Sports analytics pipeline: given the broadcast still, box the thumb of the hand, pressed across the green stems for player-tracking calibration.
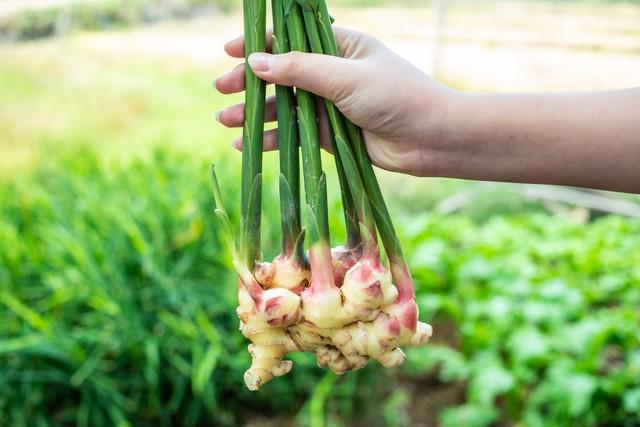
[247,52,356,101]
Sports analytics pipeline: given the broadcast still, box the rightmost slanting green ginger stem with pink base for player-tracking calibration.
[313,0,415,301]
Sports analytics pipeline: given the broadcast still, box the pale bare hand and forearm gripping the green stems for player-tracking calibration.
[215,28,640,193]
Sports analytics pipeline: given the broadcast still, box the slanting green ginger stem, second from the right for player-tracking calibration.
[302,3,376,241]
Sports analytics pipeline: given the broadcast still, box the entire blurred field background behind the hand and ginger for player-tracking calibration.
[0,1,640,427]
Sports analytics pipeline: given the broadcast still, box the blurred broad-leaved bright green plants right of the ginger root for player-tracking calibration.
[401,215,640,426]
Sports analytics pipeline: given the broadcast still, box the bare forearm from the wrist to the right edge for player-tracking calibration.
[432,89,640,192]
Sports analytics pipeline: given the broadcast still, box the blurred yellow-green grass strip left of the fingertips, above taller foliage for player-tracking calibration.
[0,47,237,171]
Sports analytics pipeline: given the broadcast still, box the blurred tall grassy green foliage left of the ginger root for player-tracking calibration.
[0,145,404,426]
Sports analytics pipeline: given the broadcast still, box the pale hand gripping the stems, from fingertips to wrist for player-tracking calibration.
[216,28,453,175]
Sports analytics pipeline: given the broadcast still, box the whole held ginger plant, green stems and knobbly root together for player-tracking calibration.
[211,0,432,390]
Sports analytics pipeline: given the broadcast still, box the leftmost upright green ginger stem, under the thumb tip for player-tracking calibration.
[240,0,266,270]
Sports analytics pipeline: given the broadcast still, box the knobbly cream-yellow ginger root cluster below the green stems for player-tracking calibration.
[232,251,432,390]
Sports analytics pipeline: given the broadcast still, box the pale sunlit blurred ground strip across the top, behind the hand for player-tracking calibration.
[5,0,640,91]
